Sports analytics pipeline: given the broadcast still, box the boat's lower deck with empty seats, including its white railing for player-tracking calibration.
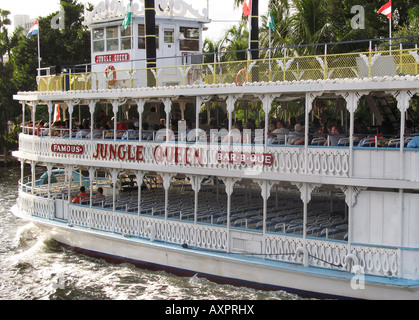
[18,171,403,279]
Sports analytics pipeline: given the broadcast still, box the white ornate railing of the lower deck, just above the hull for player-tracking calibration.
[18,192,400,277]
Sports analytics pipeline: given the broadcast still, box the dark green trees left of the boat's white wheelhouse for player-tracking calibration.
[0,0,91,147]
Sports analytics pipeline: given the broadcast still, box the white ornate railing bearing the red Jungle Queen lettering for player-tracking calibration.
[19,135,349,177]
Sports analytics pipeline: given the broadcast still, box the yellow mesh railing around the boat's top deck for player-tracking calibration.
[37,48,419,91]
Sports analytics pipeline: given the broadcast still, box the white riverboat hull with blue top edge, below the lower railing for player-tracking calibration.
[12,206,419,300]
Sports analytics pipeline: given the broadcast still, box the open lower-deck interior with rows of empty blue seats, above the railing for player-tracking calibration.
[27,176,348,240]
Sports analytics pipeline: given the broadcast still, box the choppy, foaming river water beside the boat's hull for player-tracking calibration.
[0,165,303,300]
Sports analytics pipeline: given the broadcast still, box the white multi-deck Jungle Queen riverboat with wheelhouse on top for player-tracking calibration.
[9,0,419,299]
